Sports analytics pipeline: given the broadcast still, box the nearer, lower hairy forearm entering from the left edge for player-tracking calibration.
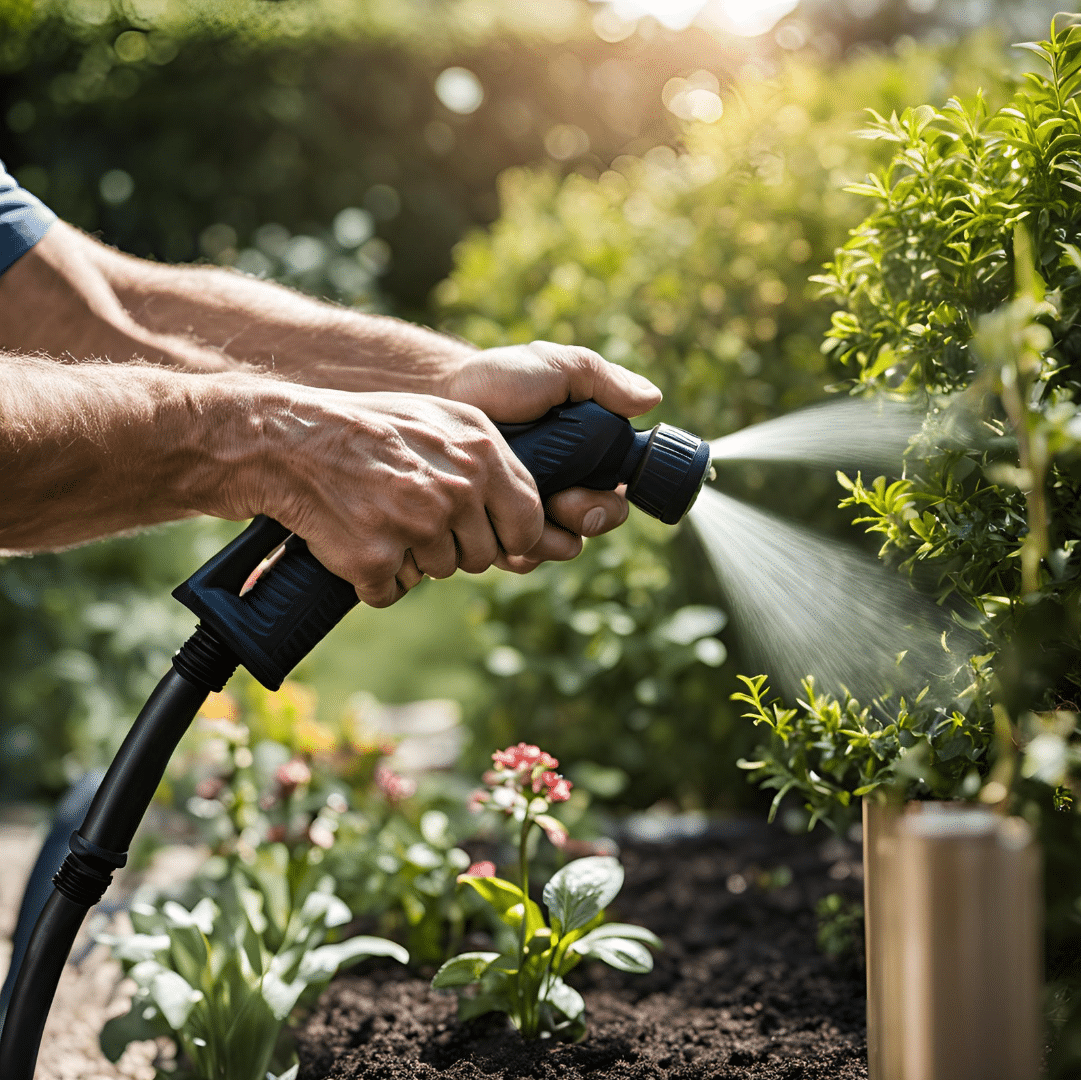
[0,354,261,554]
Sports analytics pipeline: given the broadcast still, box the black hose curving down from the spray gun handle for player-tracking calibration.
[0,626,238,1080]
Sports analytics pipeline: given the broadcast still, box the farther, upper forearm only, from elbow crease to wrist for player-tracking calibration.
[84,228,476,395]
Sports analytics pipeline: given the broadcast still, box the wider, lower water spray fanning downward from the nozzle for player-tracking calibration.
[690,486,978,703]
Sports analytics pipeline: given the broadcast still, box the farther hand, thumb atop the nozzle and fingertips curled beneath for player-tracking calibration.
[442,342,660,573]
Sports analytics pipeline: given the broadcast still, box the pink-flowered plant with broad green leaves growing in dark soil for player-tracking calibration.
[431,743,660,1041]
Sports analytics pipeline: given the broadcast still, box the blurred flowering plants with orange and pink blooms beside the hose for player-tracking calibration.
[170,680,469,963]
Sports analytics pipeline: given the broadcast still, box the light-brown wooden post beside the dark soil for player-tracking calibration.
[864,800,1042,1080]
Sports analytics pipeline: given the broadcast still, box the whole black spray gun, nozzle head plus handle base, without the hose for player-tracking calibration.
[173,401,710,690]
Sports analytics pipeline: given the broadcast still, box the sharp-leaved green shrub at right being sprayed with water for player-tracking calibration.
[744,17,1081,1077]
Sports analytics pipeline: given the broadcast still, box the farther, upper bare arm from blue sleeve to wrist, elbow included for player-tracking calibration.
[0,222,476,395]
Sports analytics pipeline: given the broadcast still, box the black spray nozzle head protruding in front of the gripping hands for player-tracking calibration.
[497,401,710,525]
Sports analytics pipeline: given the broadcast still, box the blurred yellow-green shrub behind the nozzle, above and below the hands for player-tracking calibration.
[437,31,1005,805]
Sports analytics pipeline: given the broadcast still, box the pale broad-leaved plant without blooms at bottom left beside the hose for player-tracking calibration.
[101,844,409,1080]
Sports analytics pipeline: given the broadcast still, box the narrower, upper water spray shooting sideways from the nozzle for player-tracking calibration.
[709,398,926,474]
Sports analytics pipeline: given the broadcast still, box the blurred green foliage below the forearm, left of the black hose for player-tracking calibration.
[0,522,228,800]
